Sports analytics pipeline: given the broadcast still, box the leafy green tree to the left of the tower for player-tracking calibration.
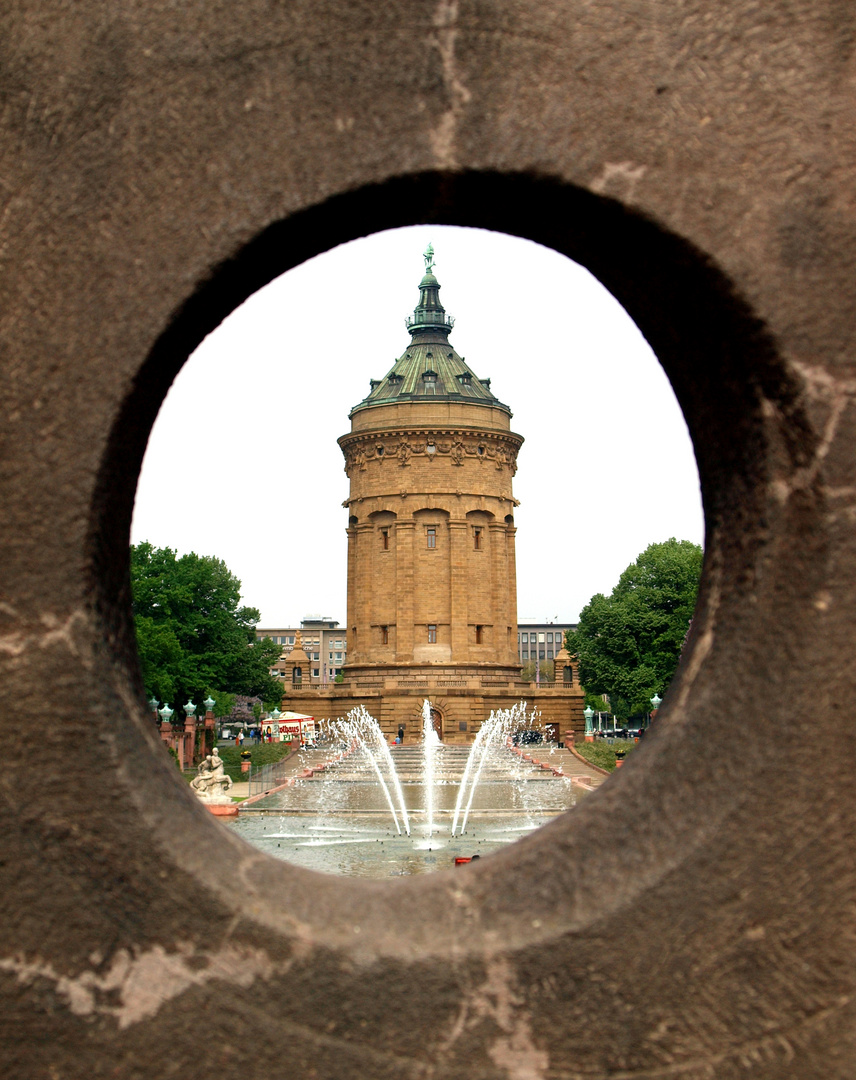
[131,542,282,708]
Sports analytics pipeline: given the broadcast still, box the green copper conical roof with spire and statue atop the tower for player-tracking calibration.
[351,244,512,416]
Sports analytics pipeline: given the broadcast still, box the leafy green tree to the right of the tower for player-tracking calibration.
[567,537,702,719]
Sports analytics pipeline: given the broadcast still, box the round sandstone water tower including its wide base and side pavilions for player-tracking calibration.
[276,246,583,743]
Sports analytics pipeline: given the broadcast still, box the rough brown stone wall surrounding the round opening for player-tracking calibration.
[0,0,856,1080]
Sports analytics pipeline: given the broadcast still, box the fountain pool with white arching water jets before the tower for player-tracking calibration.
[228,700,580,877]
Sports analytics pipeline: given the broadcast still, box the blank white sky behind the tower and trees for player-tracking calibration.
[132,226,704,627]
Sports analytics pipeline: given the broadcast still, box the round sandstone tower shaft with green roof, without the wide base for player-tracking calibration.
[339,246,522,678]
